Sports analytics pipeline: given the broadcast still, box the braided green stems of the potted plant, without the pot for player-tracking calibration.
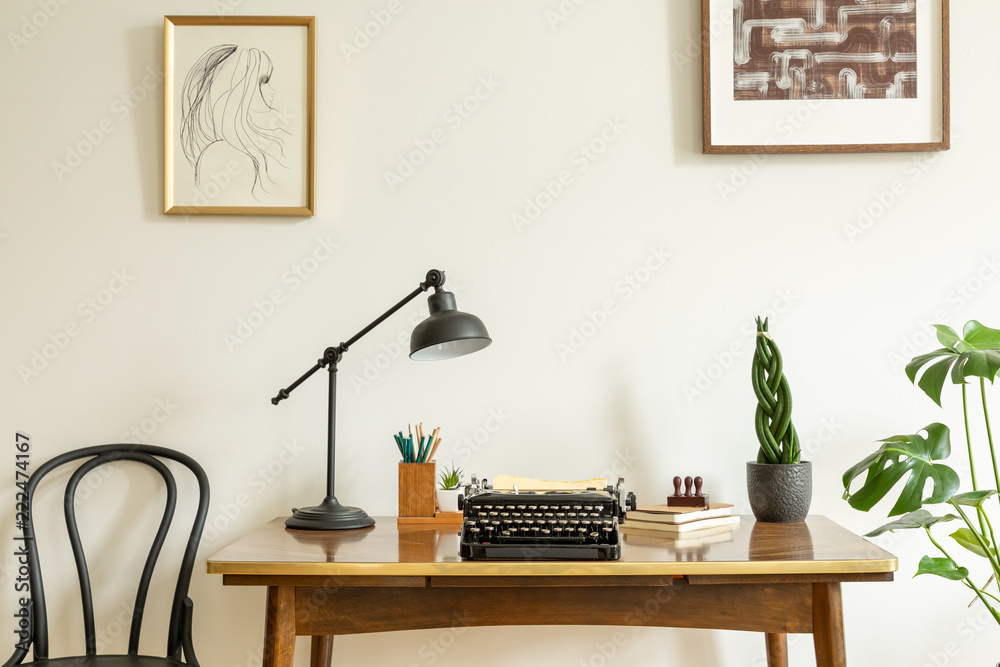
[751,317,802,463]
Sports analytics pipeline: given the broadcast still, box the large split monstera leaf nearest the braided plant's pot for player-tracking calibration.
[843,423,959,516]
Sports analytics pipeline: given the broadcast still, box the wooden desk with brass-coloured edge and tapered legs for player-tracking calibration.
[208,516,897,667]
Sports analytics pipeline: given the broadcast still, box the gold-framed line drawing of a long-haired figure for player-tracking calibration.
[163,16,316,216]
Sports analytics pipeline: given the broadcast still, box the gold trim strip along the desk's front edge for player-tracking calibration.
[206,558,899,577]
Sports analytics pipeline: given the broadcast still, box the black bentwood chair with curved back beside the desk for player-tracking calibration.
[3,445,209,667]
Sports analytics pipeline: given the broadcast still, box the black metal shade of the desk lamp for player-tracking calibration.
[410,291,493,361]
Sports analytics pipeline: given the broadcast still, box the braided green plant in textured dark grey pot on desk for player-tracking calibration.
[747,317,812,523]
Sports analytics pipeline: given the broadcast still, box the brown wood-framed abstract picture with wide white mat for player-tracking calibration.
[702,0,951,154]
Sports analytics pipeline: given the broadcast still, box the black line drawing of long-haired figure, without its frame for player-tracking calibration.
[180,44,290,199]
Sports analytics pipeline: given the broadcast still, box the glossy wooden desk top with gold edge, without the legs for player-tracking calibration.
[207,516,897,576]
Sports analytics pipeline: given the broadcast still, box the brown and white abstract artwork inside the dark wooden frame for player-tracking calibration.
[733,0,917,100]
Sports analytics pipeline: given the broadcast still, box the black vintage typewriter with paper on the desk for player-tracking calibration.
[459,478,635,560]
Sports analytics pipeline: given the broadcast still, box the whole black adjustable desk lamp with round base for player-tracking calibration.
[271,269,493,530]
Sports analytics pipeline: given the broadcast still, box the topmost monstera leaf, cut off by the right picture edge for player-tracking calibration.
[906,320,1000,405]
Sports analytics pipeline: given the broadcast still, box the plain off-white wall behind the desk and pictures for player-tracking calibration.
[0,0,1000,667]
